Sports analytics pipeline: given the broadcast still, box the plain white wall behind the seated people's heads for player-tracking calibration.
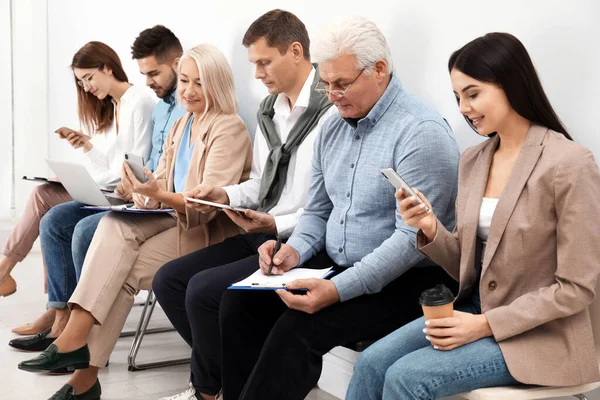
[48,0,600,162]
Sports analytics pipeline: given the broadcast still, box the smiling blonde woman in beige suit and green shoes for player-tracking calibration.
[19,44,252,399]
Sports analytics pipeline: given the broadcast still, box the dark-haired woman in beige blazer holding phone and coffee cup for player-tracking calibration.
[347,33,600,400]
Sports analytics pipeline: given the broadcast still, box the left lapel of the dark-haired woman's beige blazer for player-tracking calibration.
[460,135,499,282]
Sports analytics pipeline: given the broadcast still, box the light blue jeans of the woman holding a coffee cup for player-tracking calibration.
[346,294,518,400]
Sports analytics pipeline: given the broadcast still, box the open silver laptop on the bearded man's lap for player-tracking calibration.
[46,160,130,206]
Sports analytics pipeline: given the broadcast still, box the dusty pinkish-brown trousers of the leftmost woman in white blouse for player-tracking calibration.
[2,183,73,293]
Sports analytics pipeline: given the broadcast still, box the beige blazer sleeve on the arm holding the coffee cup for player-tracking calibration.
[485,149,600,341]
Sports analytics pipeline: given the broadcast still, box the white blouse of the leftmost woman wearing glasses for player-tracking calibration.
[85,85,156,189]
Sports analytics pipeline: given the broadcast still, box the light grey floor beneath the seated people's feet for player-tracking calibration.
[0,250,336,400]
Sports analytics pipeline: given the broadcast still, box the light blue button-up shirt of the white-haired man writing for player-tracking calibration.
[287,75,460,301]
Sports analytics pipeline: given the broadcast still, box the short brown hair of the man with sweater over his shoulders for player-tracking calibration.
[242,9,310,60]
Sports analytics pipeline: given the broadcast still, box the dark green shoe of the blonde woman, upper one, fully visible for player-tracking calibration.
[19,344,90,372]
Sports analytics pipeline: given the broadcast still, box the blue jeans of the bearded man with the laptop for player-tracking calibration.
[40,201,106,308]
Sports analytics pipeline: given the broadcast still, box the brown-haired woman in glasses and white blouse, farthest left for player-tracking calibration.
[0,42,155,337]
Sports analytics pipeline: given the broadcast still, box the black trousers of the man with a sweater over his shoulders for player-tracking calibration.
[152,234,275,395]
